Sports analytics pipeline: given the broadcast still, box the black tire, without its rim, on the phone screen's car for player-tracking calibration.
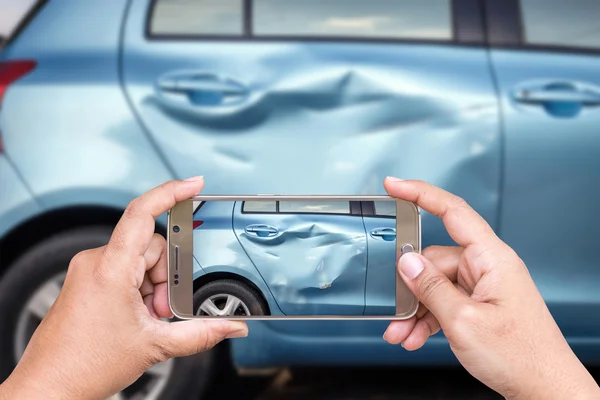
[194,279,269,315]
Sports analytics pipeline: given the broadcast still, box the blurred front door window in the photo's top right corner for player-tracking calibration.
[521,0,600,49]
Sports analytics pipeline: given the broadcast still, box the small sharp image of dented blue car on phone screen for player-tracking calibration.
[193,201,396,316]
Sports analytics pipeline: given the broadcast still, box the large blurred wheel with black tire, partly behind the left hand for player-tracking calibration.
[0,227,227,400]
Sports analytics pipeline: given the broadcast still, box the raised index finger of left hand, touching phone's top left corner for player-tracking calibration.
[108,177,204,265]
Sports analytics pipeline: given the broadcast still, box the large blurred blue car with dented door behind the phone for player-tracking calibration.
[0,0,600,399]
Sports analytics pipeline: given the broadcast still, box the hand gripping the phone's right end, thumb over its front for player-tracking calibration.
[384,178,600,399]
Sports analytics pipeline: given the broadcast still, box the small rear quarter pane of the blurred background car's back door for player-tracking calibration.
[150,0,244,35]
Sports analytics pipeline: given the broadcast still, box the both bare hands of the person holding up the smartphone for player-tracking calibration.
[0,177,600,400]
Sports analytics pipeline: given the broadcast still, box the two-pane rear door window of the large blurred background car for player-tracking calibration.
[149,0,453,40]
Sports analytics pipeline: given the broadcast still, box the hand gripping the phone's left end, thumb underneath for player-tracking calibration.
[0,177,248,399]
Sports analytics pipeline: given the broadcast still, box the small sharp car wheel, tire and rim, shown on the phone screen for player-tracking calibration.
[194,279,269,316]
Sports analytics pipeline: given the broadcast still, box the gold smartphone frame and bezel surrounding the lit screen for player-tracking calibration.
[167,194,421,321]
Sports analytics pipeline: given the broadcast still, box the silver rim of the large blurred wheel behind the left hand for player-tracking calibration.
[14,272,174,400]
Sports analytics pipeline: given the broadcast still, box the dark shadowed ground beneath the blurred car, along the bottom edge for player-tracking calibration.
[203,368,600,400]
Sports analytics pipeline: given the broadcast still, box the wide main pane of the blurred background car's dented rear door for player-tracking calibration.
[252,0,452,40]
